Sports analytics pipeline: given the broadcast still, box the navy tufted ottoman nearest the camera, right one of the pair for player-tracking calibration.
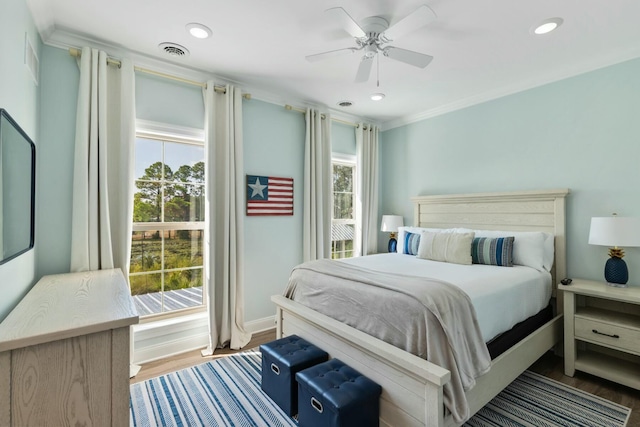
[296,359,382,427]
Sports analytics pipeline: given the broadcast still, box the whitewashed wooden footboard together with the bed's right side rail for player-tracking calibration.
[271,295,562,427]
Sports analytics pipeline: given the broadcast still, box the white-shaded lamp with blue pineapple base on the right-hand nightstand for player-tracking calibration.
[589,214,640,288]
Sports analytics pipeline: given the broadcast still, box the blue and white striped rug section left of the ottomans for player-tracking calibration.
[130,351,297,427]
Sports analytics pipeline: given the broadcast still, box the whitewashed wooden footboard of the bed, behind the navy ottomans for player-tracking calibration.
[271,295,451,427]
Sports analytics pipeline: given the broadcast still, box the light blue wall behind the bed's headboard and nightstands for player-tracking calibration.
[380,56,640,285]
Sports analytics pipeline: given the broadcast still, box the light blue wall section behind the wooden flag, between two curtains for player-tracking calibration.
[243,100,305,321]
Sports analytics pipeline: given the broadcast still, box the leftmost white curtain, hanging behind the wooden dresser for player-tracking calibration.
[70,47,135,277]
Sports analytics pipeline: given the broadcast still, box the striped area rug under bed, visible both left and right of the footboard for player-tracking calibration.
[130,351,631,427]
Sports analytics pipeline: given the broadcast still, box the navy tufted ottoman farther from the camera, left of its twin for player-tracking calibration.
[260,335,329,416]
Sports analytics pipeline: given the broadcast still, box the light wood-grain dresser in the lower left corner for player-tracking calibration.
[0,269,138,427]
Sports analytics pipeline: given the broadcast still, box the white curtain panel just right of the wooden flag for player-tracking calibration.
[302,109,333,261]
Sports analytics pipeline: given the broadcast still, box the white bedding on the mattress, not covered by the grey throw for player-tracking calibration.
[341,253,551,342]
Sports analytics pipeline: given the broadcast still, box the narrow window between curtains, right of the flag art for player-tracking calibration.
[331,157,356,259]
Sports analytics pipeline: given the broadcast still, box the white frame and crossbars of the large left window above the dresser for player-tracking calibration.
[129,120,208,323]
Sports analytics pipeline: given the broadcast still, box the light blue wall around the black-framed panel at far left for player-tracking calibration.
[0,0,42,321]
